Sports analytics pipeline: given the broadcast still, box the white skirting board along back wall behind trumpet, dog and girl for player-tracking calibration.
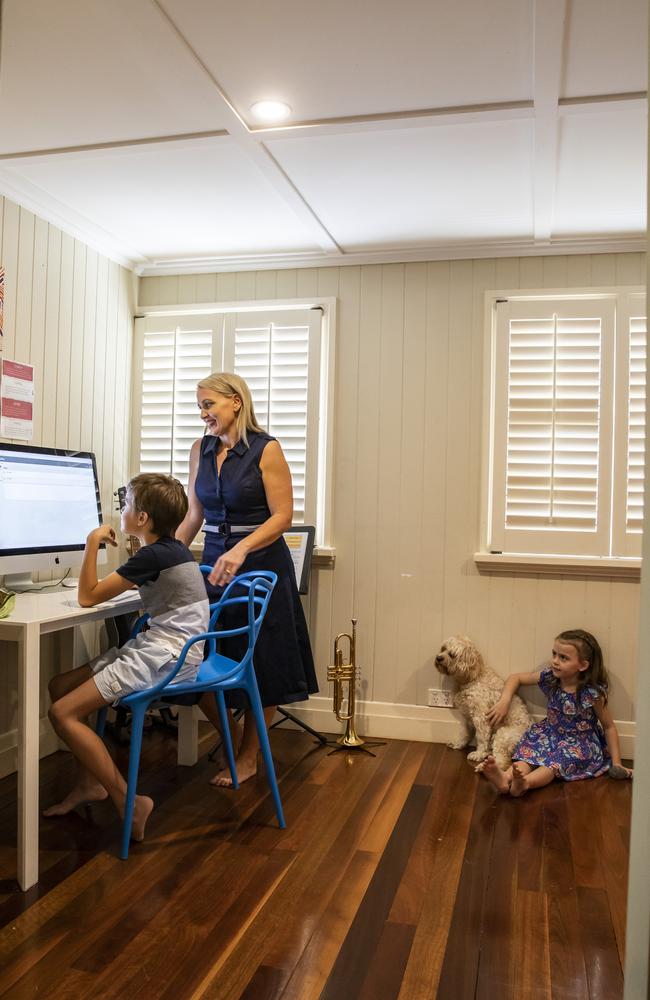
[284,696,635,760]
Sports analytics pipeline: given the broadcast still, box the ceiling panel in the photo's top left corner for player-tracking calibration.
[0,0,227,153]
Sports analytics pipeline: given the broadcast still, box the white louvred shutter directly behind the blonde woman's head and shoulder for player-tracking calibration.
[224,309,321,524]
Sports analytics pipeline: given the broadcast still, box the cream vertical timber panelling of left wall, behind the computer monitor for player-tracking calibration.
[0,198,137,774]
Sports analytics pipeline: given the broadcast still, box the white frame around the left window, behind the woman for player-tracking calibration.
[129,296,338,558]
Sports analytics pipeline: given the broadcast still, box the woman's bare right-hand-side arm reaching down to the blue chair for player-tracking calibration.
[208,441,293,586]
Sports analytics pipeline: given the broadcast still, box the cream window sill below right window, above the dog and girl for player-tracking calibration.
[474,552,641,582]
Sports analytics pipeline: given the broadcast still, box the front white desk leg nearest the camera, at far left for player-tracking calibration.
[17,624,41,891]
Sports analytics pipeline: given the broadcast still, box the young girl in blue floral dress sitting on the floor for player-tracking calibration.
[483,629,632,796]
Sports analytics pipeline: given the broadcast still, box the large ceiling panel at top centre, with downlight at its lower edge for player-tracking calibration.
[165,0,532,124]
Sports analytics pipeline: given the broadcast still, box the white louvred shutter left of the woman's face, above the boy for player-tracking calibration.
[137,316,215,486]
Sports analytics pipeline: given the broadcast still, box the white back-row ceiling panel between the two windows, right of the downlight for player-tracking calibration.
[269,121,532,250]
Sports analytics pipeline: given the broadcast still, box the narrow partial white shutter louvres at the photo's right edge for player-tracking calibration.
[625,316,646,532]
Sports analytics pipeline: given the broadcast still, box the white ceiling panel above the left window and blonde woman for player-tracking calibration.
[3,139,313,259]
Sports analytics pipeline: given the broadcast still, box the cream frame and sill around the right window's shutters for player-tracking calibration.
[474,285,647,579]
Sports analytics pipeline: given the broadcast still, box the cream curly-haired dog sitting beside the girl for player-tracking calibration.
[435,635,533,771]
